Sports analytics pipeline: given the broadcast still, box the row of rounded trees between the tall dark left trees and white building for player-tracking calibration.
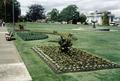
[26,4,87,24]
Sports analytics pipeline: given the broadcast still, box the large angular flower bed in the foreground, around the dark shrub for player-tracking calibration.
[33,46,120,73]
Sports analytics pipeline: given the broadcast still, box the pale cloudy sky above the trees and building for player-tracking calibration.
[18,0,120,16]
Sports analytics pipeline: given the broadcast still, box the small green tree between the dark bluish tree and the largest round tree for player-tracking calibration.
[48,8,59,21]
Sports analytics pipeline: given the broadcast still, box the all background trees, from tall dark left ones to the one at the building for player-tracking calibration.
[0,0,109,24]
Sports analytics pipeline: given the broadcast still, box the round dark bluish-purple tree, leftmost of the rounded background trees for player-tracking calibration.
[26,4,45,21]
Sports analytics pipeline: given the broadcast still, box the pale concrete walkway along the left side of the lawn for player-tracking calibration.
[0,27,32,81]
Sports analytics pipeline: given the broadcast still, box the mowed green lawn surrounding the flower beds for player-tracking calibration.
[9,23,120,81]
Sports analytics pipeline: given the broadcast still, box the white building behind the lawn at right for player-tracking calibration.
[86,11,114,25]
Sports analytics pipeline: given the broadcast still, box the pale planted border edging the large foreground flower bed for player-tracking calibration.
[32,47,120,73]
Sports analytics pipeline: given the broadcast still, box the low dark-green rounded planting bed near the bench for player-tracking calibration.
[17,31,48,41]
